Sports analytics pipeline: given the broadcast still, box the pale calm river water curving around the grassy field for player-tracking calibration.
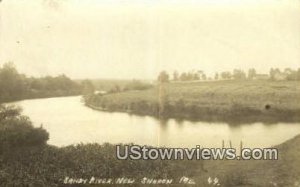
[9,96,300,147]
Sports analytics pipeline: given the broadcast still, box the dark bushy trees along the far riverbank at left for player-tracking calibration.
[0,63,93,102]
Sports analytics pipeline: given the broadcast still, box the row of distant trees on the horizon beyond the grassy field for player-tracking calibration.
[158,68,300,82]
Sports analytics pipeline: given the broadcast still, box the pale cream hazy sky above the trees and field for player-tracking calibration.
[0,0,300,79]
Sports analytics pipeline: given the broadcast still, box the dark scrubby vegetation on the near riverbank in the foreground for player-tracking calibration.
[0,106,300,187]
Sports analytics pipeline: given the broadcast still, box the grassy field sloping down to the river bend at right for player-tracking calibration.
[86,81,300,122]
